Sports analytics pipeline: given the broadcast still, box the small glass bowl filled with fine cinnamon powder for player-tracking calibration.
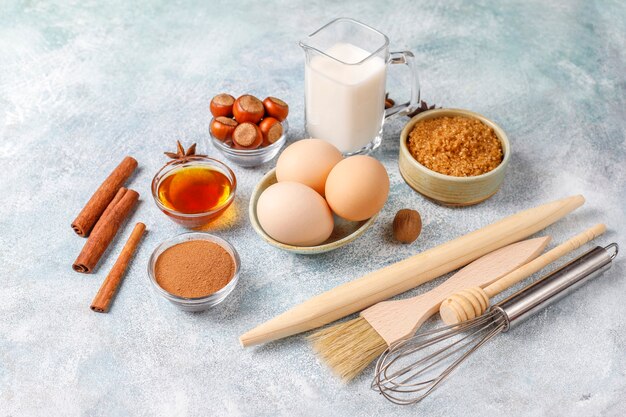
[148,232,240,311]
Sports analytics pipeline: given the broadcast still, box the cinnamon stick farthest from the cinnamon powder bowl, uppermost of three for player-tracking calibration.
[72,156,137,237]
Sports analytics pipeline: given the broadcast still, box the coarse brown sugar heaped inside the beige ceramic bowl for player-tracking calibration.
[407,116,503,177]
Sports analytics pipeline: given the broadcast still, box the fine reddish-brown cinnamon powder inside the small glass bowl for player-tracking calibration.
[154,240,235,298]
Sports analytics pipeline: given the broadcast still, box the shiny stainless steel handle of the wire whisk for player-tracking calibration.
[492,243,618,331]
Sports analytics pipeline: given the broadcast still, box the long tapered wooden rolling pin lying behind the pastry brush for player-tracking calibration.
[239,195,585,347]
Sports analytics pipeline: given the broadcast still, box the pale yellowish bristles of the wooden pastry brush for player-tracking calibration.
[308,317,387,382]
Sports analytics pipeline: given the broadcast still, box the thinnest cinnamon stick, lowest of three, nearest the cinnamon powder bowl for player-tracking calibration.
[91,223,146,313]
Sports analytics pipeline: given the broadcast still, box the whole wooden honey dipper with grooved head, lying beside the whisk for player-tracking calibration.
[439,223,606,325]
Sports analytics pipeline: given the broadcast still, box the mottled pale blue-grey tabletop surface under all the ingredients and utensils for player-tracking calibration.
[0,0,626,416]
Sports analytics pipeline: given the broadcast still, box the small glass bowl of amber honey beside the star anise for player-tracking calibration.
[152,156,237,229]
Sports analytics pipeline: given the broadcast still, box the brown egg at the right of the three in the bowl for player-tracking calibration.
[326,155,389,221]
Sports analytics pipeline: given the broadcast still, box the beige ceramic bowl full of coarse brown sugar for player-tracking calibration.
[398,109,511,206]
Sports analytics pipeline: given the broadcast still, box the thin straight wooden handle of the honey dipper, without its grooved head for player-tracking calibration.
[485,223,606,298]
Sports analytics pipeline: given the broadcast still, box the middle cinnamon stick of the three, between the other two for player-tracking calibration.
[72,190,139,274]
